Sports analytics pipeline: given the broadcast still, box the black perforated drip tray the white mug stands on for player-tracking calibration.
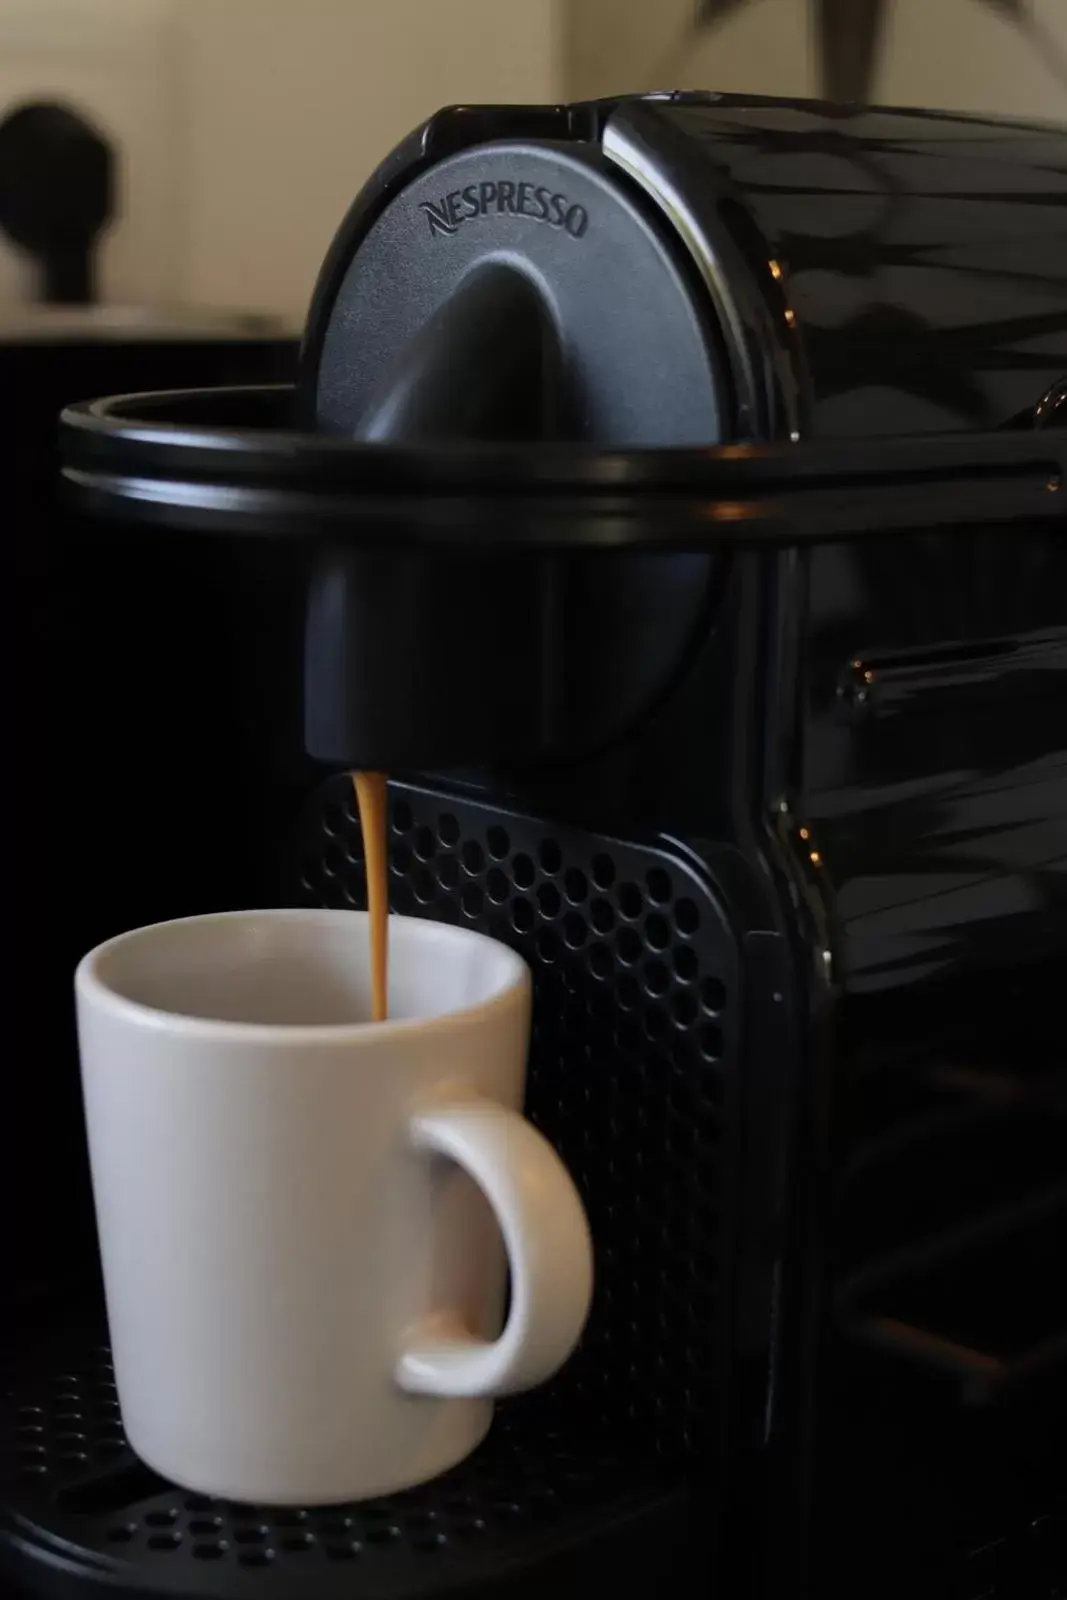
[0,1323,689,1600]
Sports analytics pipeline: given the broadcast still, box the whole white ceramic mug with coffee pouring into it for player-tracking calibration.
[77,910,592,1504]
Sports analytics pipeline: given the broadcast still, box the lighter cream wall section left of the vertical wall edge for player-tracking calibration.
[0,0,563,323]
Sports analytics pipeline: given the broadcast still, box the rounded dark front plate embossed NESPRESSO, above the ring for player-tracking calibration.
[306,139,734,448]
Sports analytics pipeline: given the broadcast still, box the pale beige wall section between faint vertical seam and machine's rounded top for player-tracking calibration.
[173,0,558,317]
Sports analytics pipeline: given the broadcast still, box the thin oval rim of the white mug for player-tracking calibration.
[74,906,531,1046]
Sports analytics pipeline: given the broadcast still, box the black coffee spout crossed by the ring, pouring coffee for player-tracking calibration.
[304,264,563,771]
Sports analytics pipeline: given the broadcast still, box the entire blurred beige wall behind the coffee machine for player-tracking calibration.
[0,0,1067,322]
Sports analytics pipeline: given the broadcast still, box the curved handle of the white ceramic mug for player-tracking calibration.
[397,1101,593,1398]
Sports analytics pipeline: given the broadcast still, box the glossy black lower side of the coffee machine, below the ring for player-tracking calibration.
[793,526,1067,1595]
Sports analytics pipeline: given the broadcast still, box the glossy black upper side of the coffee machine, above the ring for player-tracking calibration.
[653,94,1067,438]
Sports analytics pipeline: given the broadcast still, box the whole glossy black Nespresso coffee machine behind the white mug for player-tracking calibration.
[0,93,1067,1600]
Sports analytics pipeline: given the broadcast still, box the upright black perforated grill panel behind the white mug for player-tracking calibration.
[298,776,739,1459]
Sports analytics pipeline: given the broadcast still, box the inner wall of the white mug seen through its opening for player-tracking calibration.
[94,910,523,1027]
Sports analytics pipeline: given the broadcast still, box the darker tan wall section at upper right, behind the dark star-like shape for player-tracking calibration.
[566,0,1067,122]
